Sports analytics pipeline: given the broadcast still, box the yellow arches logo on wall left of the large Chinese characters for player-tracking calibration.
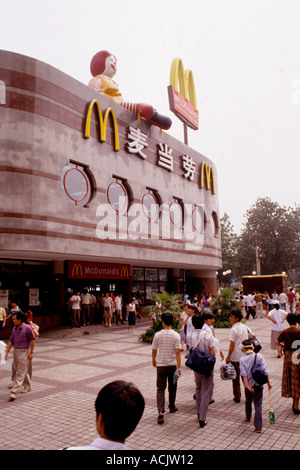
[84,100,120,152]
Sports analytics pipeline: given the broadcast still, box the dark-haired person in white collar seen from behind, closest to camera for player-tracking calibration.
[65,380,145,450]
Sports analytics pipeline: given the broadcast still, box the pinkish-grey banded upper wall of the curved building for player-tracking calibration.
[0,51,222,326]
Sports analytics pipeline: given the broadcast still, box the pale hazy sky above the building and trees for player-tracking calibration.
[0,0,300,233]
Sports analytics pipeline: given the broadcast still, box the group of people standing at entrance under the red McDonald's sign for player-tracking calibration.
[68,290,141,332]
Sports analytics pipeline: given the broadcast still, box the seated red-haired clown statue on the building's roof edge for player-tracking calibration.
[88,51,172,130]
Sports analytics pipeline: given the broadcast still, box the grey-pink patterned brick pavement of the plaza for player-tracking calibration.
[0,318,300,451]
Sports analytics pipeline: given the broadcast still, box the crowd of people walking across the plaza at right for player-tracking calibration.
[152,292,300,433]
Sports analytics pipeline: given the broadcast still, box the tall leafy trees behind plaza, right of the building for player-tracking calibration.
[219,197,300,284]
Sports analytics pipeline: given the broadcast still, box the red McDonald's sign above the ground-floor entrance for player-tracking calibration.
[68,261,130,280]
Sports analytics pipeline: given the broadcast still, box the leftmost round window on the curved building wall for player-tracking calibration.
[62,163,91,206]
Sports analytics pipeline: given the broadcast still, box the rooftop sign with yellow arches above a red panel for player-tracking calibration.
[168,58,199,130]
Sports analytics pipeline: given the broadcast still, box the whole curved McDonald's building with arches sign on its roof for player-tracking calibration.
[0,51,222,329]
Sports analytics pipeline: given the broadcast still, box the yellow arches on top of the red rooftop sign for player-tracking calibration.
[170,57,198,111]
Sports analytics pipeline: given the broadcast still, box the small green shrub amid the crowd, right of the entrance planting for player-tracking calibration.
[211,288,241,328]
